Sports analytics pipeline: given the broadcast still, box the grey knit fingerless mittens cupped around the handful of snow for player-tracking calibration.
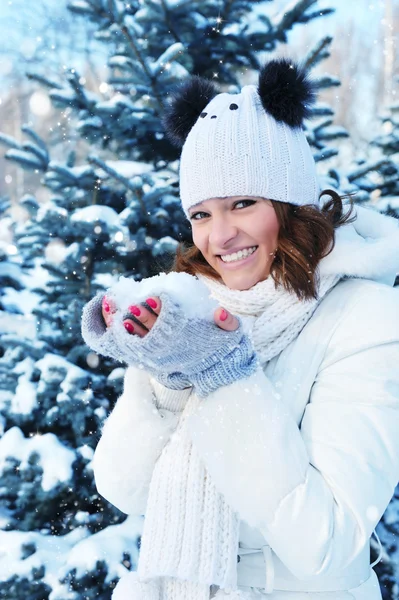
[82,292,257,396]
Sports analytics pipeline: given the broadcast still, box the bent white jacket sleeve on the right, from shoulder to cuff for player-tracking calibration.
[188,289,399,579]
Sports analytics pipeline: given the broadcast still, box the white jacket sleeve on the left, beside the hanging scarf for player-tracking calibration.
[92,367,191,515]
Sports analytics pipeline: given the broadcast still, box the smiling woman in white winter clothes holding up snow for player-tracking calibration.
[82,60,399,600]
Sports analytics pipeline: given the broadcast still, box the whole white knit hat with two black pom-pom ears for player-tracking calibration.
[164,59,321,215]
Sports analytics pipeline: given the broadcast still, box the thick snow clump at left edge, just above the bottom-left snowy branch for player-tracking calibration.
[0,427,76,491]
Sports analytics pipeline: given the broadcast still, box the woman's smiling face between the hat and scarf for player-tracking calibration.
[189,196,280,290]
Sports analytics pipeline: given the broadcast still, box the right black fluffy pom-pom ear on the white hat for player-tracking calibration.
[258,58,316,127]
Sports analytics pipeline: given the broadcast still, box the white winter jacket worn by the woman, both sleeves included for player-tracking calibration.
[93,279,399,600]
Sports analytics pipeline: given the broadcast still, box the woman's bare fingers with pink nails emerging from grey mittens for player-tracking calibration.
[102,296,239,337]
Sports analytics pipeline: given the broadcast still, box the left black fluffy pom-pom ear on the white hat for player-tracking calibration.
[162,75,217,147]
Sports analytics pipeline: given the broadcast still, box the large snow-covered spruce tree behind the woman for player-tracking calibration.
[0,0,393,600]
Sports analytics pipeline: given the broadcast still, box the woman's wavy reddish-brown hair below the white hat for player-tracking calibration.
[171,190,356,300]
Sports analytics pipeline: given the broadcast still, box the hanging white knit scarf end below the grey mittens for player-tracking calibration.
[137,394,240,600]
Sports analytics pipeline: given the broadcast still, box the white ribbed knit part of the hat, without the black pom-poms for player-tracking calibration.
[179,85,320,216]
